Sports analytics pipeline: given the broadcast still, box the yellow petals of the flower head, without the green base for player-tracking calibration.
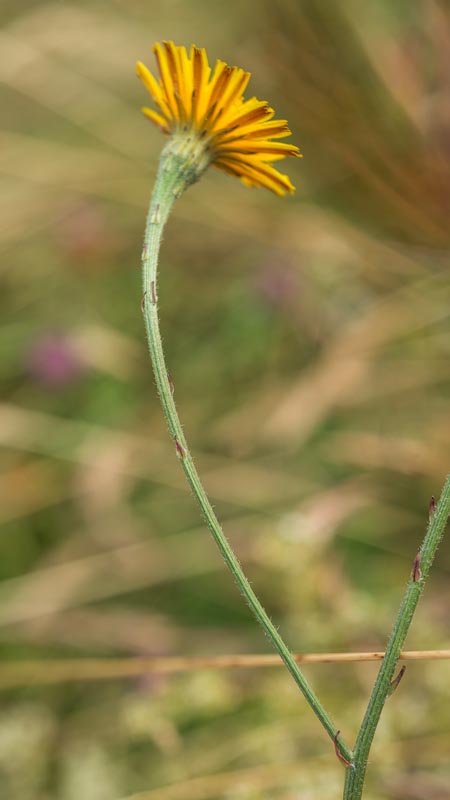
[136,42,301,195]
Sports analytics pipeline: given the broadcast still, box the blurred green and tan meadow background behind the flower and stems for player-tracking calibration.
[0,0,450,800]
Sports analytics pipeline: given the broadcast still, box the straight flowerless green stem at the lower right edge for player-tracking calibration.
[344,475,450,800]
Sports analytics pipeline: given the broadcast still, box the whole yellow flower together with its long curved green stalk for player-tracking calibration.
[137,42,352,763]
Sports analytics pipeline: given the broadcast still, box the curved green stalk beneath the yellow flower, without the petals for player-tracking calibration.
[142,142,352,761]
